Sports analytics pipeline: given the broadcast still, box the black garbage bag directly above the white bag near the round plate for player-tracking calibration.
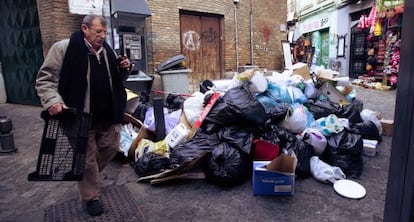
[322,129,363,179]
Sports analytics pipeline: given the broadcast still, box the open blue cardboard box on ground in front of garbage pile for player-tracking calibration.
[252,153,297,195]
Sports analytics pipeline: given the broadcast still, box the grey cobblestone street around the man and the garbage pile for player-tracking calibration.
[0,86,396,222]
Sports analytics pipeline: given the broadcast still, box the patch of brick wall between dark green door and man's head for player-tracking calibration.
[37,0,83,55]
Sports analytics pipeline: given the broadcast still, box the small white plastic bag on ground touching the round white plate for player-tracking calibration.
[310,156,346,183]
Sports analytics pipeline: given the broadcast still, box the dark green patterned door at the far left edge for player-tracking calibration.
[0,0,43,105]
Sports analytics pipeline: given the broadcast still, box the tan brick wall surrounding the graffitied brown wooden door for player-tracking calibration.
[147,0,287,74]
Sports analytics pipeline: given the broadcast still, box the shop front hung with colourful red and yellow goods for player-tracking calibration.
[353,0,404,89]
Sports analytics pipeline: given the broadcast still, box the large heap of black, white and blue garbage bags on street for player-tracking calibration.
[121,69,382,186]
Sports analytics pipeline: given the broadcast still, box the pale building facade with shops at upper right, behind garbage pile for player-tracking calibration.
[288,0,404,87]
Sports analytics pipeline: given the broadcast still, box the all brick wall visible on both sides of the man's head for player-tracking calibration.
[37,0,287,73]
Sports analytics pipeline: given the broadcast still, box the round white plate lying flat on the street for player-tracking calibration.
[334,180,367,199]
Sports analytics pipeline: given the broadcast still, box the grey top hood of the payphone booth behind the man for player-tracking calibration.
[111,0,151,17]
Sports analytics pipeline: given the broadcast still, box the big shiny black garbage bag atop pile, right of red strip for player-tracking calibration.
[206,81,267,127]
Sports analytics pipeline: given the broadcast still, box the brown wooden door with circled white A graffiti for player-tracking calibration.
[180,14,223,91]
